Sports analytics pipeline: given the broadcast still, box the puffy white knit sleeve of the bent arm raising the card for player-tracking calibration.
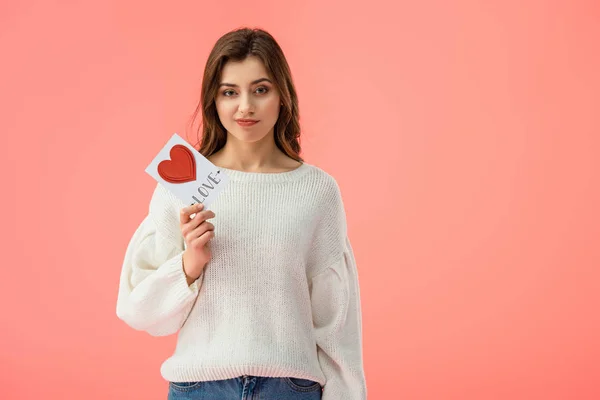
[117,184,204,336]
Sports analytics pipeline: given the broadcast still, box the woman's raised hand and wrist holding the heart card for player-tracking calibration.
[179,203,215,285]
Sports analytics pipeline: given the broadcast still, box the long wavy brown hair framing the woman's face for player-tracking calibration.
[190,28,304,162]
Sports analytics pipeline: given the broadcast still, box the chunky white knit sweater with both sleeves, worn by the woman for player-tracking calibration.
[117,163,367,400]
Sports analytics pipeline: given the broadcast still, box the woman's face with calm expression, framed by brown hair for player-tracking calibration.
[215,56,281,142]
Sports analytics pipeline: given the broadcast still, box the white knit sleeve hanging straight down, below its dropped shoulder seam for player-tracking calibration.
[310,237,367,400]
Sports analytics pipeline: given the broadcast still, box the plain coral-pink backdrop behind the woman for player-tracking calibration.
[0,0,600,400]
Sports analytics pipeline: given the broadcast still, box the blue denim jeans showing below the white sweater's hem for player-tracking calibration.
[168,375,323,400]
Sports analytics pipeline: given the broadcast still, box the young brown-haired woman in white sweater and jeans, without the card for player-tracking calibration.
[117,29,366,400]
